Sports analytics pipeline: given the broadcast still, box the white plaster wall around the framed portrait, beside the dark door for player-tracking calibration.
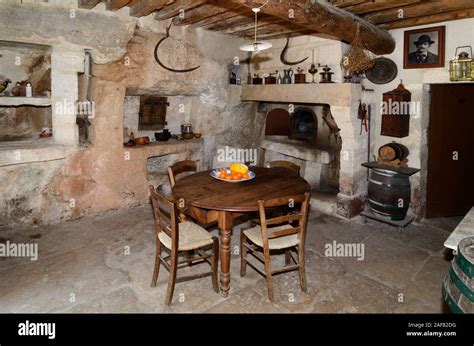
[366,18,474,217]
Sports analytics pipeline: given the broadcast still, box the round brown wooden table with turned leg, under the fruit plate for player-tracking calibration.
[173,167,311,297]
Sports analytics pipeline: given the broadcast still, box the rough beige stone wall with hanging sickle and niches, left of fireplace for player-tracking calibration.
[0,4,263,230]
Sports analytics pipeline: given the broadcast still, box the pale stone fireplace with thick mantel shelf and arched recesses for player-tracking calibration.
[241,83,368,218]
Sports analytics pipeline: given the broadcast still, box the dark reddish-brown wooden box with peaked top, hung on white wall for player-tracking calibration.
[381,83,411,138]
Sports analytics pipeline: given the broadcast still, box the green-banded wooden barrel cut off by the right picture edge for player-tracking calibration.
[442,237,474,314]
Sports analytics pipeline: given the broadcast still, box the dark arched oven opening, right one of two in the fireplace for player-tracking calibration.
[289,107,318,144]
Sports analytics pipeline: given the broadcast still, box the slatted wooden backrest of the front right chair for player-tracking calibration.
[258,192,310,249]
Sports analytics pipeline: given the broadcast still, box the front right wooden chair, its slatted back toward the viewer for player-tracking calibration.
[240,192,310,301]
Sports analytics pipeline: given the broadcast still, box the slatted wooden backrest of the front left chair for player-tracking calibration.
[149,185,179,242]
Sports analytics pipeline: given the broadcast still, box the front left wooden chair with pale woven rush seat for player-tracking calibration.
[150,185,219,305]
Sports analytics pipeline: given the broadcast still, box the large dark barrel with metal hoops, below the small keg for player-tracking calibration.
[368,168,411,221]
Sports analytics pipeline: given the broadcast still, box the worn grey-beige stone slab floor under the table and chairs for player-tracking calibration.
[0,206,461,313]
